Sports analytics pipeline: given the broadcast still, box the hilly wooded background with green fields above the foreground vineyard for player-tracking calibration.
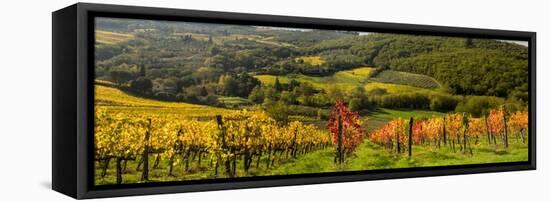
[94,19,528,114]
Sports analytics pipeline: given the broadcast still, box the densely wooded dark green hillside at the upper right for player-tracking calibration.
[303,33,528,100]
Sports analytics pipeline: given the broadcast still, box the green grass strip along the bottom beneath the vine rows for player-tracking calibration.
[96,138,528,184]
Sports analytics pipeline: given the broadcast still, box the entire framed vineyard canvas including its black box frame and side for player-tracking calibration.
[52,3,536,199]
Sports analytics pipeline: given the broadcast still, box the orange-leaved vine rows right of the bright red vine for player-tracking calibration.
[369,107,528,157]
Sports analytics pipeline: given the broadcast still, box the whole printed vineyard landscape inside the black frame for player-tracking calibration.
[93,17,531,185]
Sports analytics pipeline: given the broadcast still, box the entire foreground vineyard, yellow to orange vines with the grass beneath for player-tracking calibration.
[94,87,528,184]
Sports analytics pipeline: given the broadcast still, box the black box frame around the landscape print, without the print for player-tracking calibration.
[52,3,536,199]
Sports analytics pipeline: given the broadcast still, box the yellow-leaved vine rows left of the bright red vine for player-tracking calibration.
[94,108,331,184]
